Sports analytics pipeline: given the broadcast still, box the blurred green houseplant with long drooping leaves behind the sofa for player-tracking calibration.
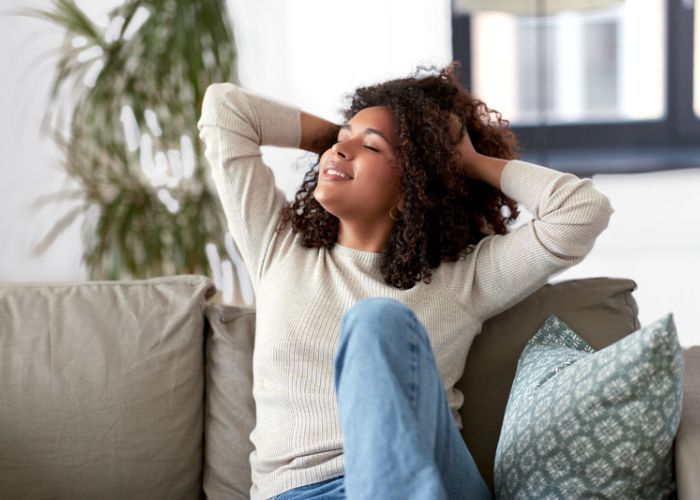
[17,0,237,279]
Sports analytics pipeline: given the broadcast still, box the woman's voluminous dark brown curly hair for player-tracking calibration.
[277,61,519,289]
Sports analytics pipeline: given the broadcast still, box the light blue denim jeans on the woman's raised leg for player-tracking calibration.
[274,298,493,500]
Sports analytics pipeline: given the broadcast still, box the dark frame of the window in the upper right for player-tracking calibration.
[452,0,700,176]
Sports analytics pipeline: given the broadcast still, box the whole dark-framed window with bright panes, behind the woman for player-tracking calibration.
[452,0,700,175]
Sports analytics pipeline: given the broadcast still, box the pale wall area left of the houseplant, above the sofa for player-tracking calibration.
[0,0,119,282]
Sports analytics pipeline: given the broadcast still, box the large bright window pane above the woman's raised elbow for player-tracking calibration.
[471,0,666,124]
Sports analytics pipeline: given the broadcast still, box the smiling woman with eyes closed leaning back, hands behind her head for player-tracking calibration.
[198,63,613,499]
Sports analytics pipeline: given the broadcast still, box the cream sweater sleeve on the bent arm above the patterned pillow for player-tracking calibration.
[436,160,614,322]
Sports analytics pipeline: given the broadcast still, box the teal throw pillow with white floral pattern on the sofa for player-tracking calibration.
[494,313,683,499]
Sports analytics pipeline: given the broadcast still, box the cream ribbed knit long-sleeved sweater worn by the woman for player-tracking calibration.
[198,83,613,500]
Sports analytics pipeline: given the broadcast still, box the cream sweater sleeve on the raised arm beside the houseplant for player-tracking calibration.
[197,83,301,291]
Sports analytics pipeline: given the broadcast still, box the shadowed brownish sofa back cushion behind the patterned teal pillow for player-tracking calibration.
[455,278,640,491]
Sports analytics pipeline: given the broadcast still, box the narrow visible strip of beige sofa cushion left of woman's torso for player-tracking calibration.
[202,304,255,500]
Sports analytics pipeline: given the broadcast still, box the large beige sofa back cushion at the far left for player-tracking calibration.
[0,276,215,499]
